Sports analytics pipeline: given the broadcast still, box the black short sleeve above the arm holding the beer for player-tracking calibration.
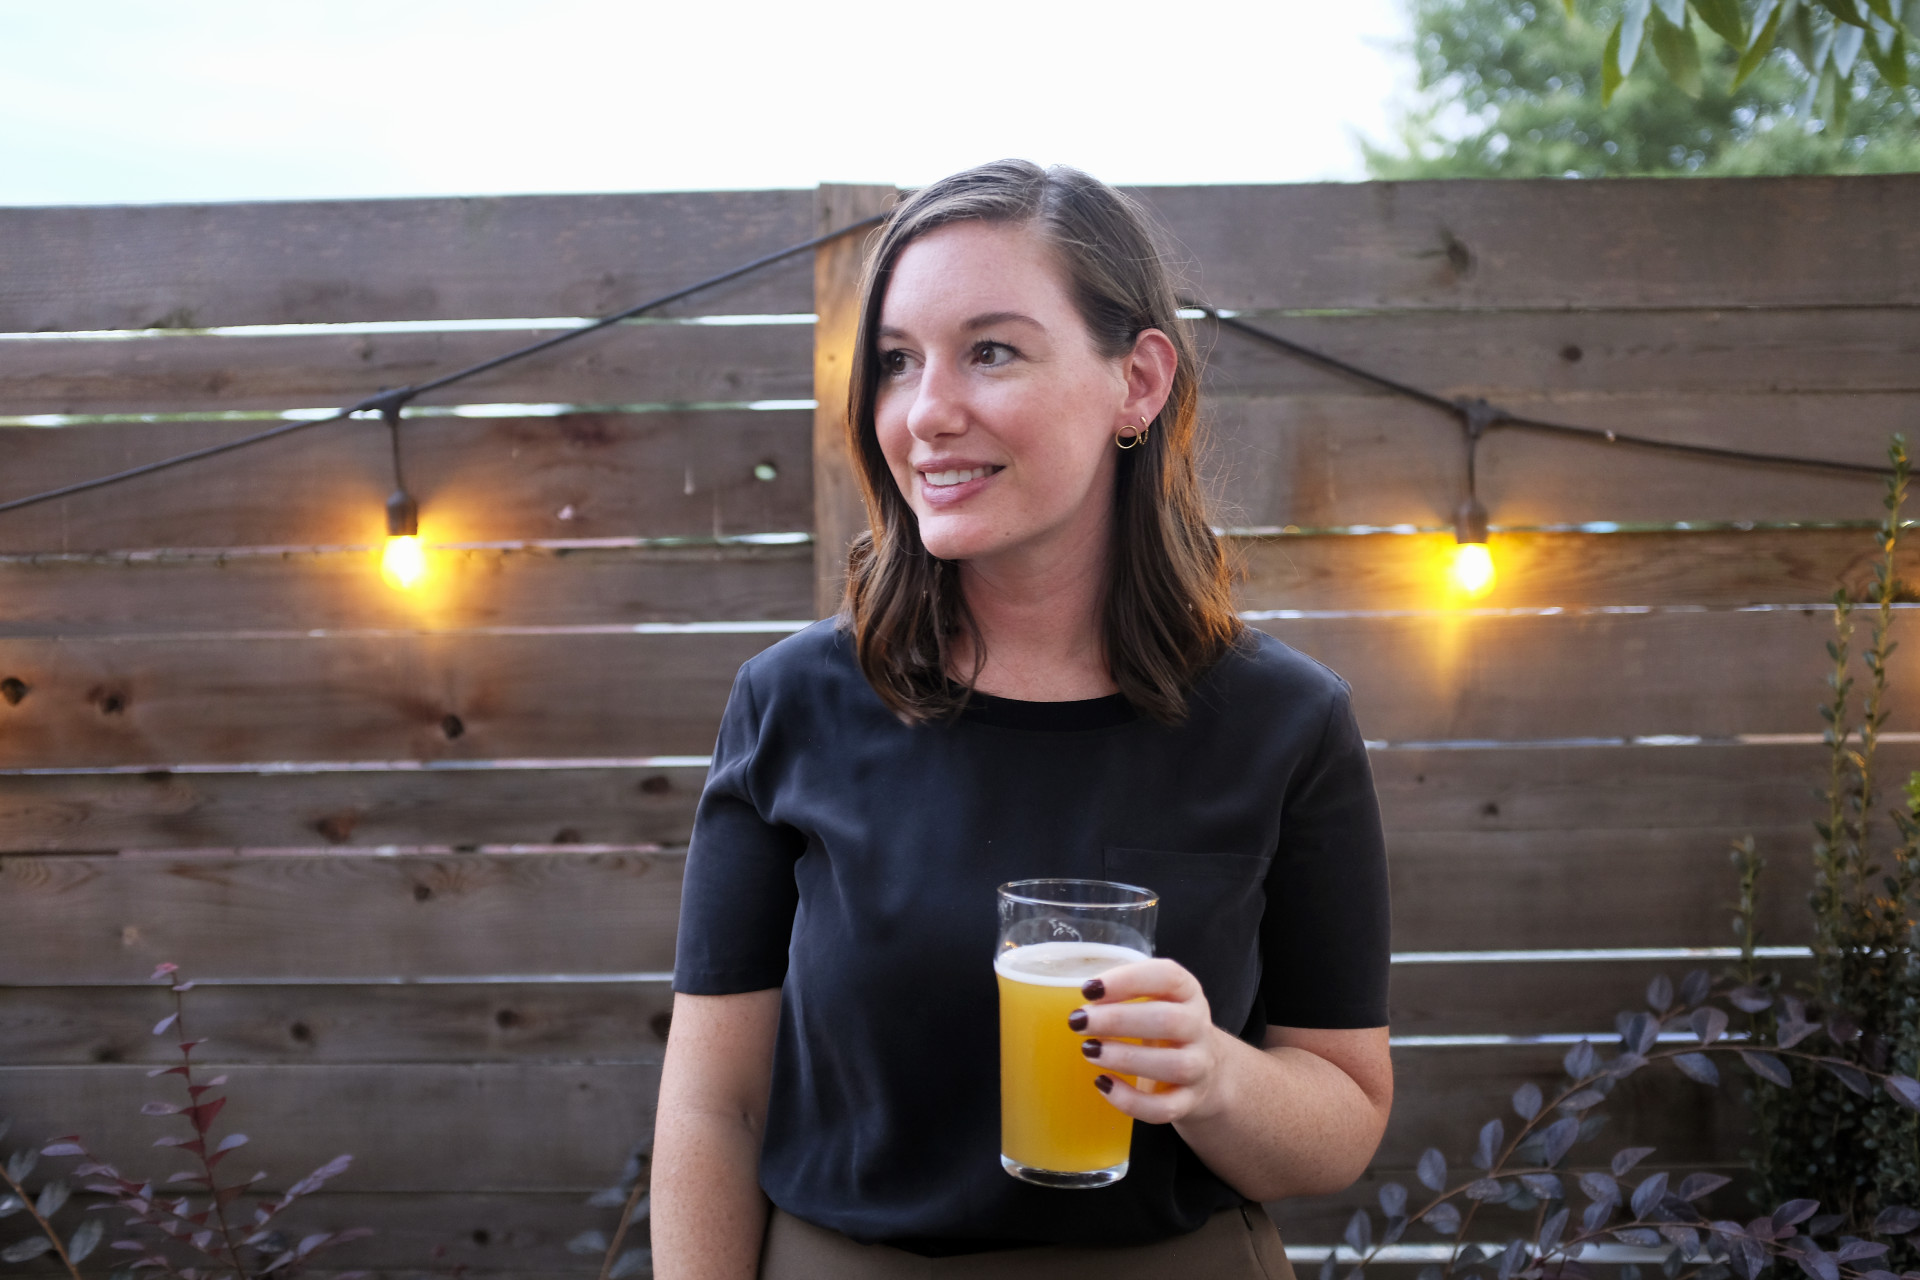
[1261,683,1390,1029]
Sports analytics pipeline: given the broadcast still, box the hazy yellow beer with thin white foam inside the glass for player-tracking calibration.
[993,942,1148,1178]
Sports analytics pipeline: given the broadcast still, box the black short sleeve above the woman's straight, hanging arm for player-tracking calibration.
[674,668,806,996]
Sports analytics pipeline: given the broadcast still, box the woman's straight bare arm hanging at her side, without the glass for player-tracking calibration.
[651,986,780,1280]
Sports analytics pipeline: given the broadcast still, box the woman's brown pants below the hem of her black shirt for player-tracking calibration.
[760,1205,1294,1280]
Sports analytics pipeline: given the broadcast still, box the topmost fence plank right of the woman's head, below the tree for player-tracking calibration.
[1135,175,1920,311]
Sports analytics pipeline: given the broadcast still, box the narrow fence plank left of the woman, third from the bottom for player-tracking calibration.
[0,982,674,1067]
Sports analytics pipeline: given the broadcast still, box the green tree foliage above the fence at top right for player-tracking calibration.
[1363,0,1920,178]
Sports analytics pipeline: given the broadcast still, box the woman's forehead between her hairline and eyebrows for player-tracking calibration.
[879,223,1073,328]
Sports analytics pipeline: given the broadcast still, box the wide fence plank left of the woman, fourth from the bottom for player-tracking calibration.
[0,852,685,986]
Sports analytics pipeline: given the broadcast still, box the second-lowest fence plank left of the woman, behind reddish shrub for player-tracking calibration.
[0,1046,660,1196]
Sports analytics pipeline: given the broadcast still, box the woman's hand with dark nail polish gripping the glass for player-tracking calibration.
[1068,960,1225,1125]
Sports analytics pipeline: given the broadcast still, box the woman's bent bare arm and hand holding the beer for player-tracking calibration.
[1085,960,1394,1199]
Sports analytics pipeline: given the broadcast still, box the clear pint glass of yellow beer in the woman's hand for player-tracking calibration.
[993,881,1160,1188]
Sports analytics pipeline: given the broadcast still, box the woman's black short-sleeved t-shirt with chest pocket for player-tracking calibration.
[674,622,1388,1253]
